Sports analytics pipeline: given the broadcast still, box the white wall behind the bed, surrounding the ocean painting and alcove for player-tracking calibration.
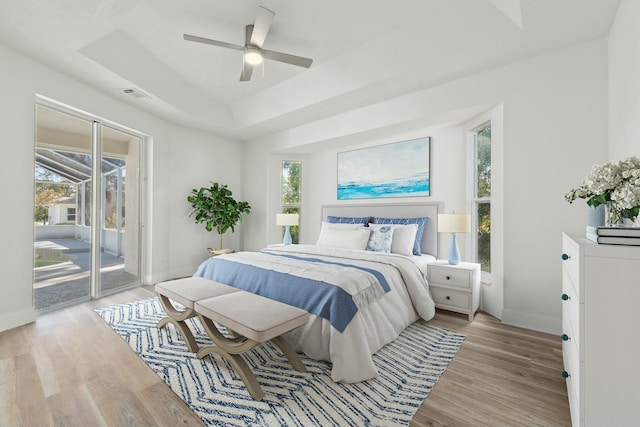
[245,40,607,332]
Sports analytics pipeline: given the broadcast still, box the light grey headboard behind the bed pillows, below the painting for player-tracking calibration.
[322,202,444,258]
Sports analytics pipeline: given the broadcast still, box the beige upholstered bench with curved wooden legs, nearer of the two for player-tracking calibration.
[194,291,309,400]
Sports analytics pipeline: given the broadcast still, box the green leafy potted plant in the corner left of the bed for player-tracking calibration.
[187,182,251,255]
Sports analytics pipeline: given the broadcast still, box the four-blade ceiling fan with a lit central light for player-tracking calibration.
[184,6,313,82]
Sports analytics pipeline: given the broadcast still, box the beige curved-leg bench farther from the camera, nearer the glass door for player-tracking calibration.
[155,277,238,353]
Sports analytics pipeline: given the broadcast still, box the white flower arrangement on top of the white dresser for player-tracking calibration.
[564,157,640,225]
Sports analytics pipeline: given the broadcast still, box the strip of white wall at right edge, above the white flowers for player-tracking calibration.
[609,0,640,162]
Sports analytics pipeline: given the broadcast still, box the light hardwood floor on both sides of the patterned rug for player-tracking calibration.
[0,287,570,427]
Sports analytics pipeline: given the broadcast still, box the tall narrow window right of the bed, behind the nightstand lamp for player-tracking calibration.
[472,123,491,273]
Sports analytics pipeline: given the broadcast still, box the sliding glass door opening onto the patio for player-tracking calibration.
[34,105,142,312]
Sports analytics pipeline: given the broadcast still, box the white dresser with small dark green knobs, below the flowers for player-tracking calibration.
[561,234,640,427]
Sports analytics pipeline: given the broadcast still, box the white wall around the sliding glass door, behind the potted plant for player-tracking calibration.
[0,45,243,331]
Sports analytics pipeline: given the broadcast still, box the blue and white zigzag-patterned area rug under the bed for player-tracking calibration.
[96,298,465,426]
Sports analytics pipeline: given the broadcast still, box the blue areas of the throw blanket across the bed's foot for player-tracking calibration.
[194,254,390,332]
